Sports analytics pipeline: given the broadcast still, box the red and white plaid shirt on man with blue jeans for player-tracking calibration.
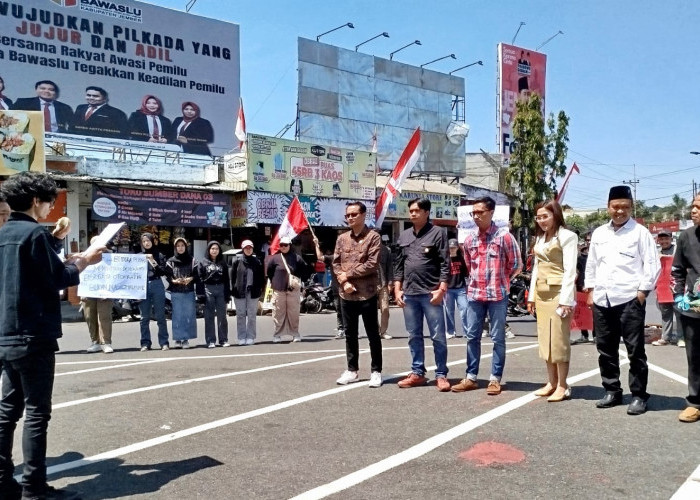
[464,222,522,301]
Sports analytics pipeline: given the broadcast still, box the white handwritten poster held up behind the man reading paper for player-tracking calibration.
[78,253,149,300]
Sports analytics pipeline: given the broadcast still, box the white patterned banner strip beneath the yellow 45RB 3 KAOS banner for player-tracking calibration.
[247,190,375,227]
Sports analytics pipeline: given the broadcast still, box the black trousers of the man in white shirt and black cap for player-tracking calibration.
[593,298,649,401]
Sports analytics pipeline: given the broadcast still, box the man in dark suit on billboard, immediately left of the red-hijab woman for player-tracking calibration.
[70,85,126,139]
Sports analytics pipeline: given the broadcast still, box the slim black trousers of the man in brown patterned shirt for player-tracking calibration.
[340,295,382,372]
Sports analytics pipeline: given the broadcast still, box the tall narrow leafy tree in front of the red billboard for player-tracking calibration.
[506,93,569,247]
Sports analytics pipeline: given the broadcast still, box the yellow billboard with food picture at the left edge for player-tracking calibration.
[0,108,46,175]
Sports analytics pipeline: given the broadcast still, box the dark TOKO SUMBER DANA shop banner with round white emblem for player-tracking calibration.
[92,185,231,227]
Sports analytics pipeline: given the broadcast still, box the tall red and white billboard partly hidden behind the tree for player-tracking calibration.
[497,43,547,165]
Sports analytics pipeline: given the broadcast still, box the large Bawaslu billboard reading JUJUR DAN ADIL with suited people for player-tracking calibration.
[0,0,240,155]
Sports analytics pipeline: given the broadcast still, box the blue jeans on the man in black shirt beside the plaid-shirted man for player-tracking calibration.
[403,293,448,378]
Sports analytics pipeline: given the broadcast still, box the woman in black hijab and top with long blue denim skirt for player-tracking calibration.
[165,238,197,349]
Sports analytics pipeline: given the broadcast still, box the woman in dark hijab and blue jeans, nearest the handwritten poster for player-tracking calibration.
[139,233,170,351]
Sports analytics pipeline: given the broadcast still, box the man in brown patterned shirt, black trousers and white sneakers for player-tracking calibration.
[333,201,382,387]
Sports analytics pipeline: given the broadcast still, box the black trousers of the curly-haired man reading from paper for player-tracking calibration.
[0,350,56,498]
